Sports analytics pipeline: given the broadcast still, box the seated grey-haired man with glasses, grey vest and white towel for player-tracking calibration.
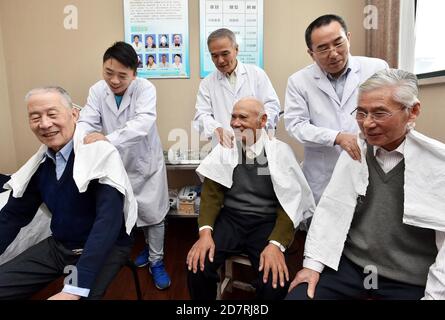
[287,69,445,299]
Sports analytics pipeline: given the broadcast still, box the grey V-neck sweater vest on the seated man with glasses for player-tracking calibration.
[343,146,437,286]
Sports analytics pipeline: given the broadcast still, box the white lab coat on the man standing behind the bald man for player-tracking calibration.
[193,61,280,138]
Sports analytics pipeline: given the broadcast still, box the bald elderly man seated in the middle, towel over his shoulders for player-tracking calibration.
[187,98,314,300]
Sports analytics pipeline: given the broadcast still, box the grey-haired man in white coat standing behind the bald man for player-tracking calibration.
[193,28,280,148]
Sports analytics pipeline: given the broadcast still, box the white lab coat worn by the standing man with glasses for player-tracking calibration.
[284,56,388,203]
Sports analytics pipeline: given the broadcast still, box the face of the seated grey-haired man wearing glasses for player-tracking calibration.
[357,87,420,151]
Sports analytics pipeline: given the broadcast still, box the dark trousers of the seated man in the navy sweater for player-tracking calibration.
[0,237,131,300]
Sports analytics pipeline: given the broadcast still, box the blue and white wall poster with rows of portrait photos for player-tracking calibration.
[124,0,190,78]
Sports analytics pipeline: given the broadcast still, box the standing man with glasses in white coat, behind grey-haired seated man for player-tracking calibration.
[284,15,388,203]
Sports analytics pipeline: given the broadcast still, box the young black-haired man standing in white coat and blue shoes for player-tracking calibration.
[77,42,171,290]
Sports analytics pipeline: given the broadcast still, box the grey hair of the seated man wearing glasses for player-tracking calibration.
[359,69,419,108]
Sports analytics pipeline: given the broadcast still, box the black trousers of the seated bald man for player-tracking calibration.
[188,208,289,300]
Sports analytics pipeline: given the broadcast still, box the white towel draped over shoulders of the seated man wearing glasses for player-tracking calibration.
[303,130,445,299]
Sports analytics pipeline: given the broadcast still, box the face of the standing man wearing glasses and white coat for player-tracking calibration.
[308,21,351,77]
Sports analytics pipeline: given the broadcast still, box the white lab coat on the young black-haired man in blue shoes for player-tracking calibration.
[76,78,169,226]
